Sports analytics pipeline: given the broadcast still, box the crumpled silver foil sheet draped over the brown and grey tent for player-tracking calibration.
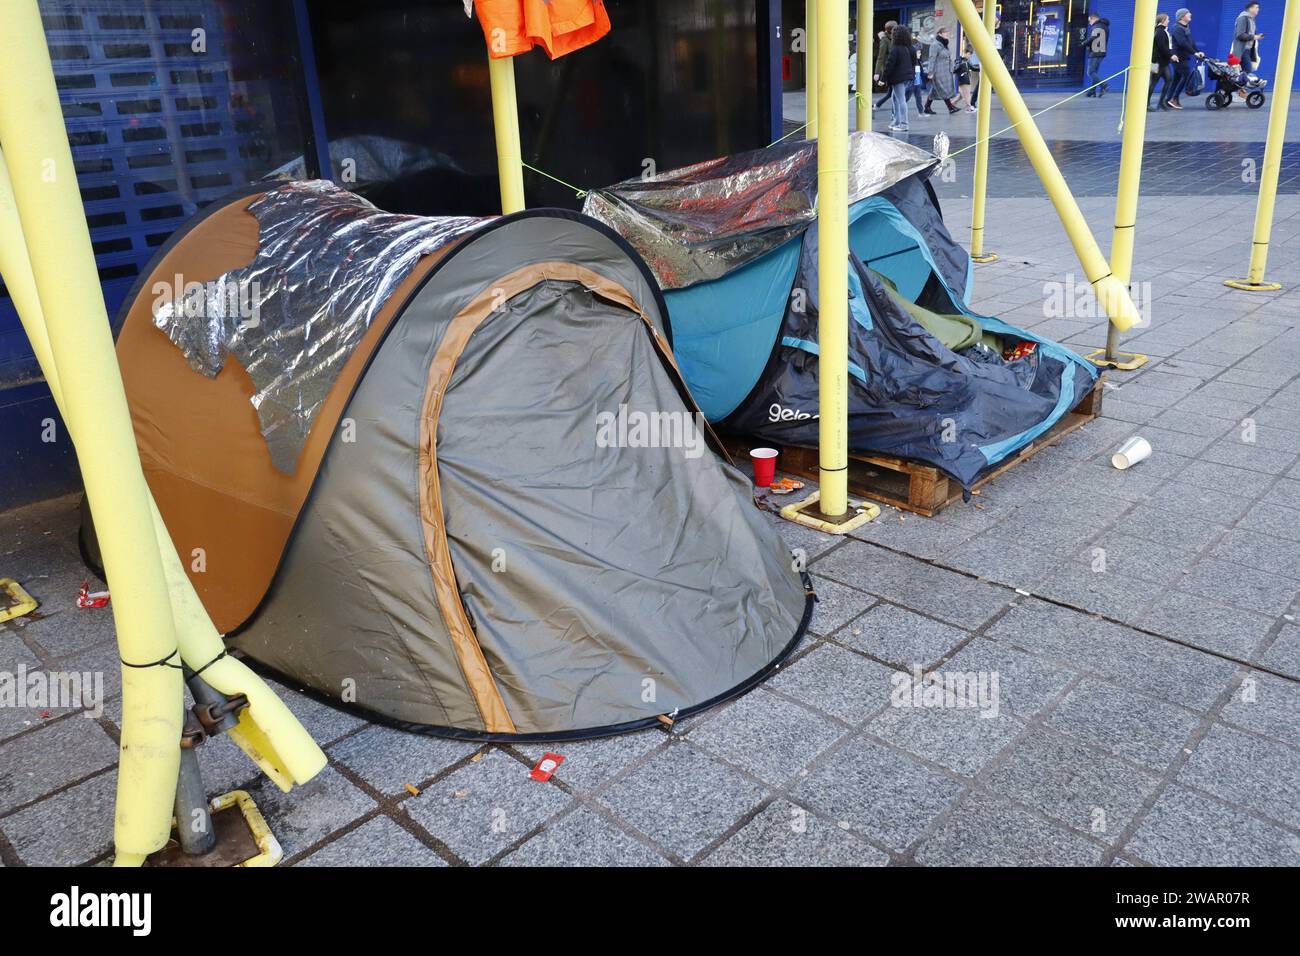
[153,179,489,475]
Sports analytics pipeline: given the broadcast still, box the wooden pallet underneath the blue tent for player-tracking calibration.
[725,378,1104,518]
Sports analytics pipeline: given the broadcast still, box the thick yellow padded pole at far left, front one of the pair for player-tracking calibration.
[0,0,182,865]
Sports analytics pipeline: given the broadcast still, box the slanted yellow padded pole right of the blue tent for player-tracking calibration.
[953,0,1139,332]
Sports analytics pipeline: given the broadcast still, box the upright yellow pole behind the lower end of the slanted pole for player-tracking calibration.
[1087,0,1156,371]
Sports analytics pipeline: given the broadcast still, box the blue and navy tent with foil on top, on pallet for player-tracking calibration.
[585,133,1097,488]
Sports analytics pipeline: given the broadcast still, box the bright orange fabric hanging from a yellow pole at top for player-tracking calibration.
[475,0,610,60]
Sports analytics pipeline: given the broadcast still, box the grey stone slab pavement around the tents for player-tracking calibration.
[0,95,1300,866]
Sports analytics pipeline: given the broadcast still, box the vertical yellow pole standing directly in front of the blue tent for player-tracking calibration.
[816,0,849,518]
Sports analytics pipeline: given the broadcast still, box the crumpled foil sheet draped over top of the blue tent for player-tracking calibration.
[582,131,939,289]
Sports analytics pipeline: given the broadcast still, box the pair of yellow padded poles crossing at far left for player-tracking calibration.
[0,0,325,865]
